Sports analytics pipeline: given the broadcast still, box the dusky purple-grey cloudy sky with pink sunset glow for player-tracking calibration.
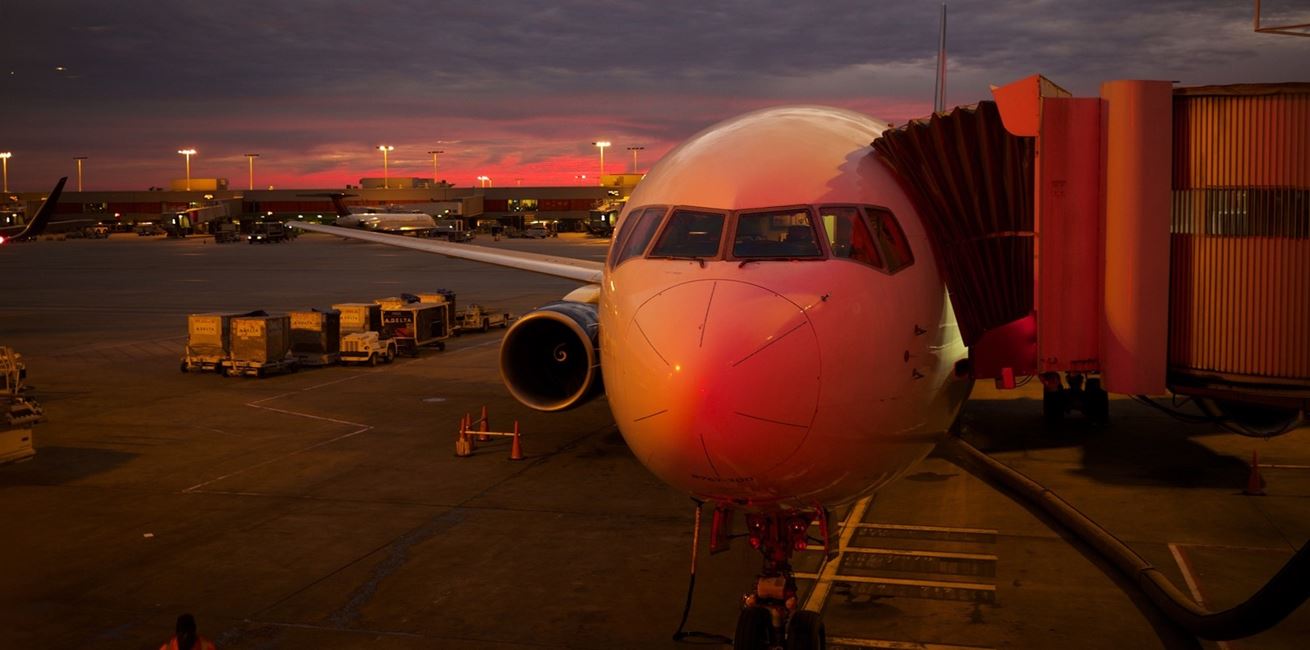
[0,0,1310,191]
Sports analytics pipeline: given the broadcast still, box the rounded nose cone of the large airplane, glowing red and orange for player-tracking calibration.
[625,280,820,484]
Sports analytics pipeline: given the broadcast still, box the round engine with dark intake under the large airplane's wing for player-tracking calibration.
[500,301,603,411]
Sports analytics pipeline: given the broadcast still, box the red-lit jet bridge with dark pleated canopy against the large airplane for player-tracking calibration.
[874,76,1310,422]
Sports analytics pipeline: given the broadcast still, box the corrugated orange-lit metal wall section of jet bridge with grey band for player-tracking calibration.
[1169,84,1310,408]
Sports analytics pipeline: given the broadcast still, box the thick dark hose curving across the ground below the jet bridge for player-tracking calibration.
[941,436,1310,641]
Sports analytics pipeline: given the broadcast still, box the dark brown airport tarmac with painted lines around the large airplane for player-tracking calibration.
[0,235,1310,650]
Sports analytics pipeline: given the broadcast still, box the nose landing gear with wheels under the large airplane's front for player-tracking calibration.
[732,511,828,650]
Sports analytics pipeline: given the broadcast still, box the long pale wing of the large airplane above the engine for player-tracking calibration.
[287,221,605,284]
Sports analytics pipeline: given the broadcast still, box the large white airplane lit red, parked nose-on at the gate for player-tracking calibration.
[291,106,972,649]
